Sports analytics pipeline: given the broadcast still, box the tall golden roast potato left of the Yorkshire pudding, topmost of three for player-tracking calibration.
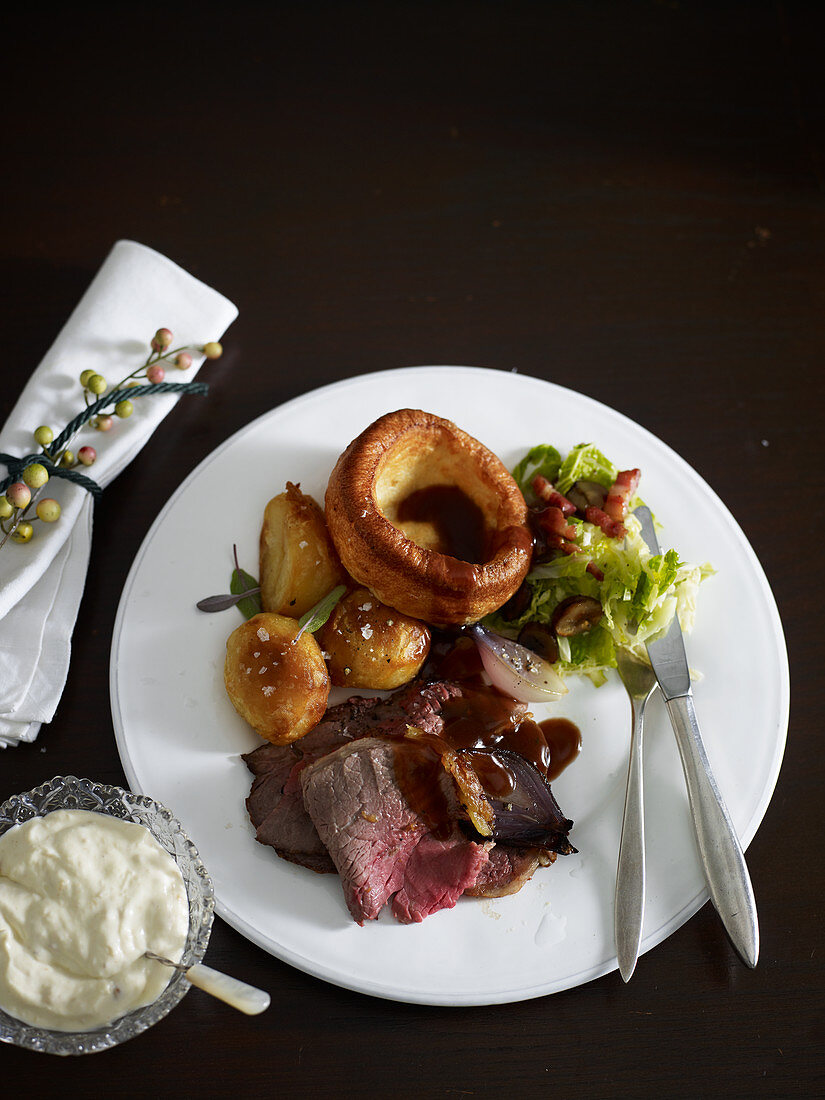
[260,482,345,618]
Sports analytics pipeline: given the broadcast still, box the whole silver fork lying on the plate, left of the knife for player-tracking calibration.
[614,649,657,981]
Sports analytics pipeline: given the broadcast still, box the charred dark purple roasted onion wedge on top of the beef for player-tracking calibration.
[481,749,576,856]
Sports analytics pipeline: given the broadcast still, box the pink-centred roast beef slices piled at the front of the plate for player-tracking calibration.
[238,680,575,924]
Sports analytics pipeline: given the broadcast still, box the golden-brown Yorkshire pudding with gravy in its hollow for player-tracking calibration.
[326,409,532,626]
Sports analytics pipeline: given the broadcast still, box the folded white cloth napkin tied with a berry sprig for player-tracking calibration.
[0,241,238,747]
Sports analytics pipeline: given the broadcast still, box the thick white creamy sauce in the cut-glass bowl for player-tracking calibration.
[0,810,189,1031]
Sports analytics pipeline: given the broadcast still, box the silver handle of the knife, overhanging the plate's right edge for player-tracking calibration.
[667,693,759,967]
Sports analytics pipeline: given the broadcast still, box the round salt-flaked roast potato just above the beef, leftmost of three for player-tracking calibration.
[223,612,330,745]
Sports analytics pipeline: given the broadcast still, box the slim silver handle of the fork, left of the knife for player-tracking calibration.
[614,701,645,981]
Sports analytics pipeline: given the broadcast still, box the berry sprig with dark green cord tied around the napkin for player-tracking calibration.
[0,328,223,550]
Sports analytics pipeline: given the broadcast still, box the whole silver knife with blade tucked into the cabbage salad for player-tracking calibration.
[634,506,759,967]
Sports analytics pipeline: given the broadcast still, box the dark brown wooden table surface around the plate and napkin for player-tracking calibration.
[0,0,825,1098]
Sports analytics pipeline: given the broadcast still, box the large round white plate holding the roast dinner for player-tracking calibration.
[110,366,789,1004]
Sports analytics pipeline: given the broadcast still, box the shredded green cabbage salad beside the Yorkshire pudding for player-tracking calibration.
[485,443,714,684]
